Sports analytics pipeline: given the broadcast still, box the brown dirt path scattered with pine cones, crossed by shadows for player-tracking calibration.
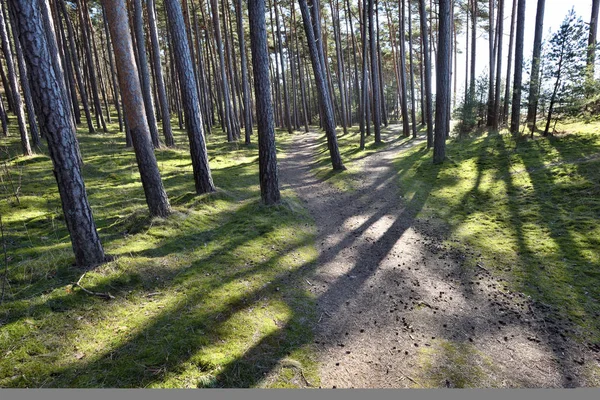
[280,129,600,388]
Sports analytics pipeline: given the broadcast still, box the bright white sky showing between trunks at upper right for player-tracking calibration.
[457,0,592,97]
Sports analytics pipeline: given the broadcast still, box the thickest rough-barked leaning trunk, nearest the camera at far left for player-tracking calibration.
[10,0,105,267]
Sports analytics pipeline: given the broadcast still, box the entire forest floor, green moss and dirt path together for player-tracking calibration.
[0,118,600,388]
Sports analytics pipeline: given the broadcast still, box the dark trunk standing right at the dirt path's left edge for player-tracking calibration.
[248,0,281,204]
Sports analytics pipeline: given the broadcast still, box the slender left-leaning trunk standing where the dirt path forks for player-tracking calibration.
[298,0,346,170]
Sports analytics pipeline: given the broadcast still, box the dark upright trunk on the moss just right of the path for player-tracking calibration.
[433,0,452,164]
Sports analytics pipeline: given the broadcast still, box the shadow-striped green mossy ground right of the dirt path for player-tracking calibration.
[322,123,600,342]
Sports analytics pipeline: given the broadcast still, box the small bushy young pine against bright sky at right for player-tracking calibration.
[544,9,588,136]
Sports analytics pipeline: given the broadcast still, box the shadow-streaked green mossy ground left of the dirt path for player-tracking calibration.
[0,116,318,387]
